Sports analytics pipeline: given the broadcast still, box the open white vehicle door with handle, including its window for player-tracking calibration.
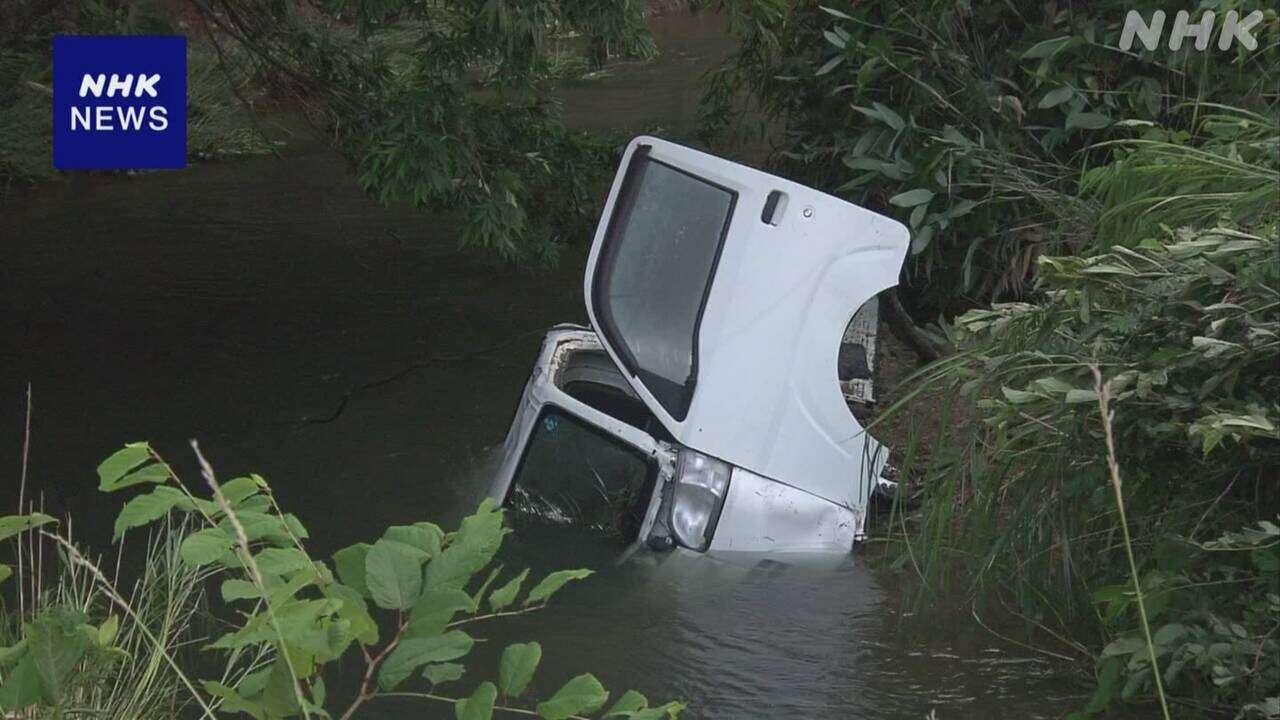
[585,137,909,511]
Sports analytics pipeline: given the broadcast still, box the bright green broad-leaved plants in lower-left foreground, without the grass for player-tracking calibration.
[0,443,684,720]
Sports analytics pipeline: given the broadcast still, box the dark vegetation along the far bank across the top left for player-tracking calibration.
[0,0,654,266]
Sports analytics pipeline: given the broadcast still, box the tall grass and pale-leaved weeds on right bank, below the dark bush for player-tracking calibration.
[873,108,1280,714]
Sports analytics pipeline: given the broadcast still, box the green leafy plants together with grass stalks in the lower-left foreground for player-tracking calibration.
[0,443,684,720]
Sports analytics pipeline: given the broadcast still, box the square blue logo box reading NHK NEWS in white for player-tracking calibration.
[54,35,187,169]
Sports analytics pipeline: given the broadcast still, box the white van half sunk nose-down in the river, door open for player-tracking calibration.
[489,137,908,552]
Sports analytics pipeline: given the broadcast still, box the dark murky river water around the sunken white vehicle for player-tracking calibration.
[0,11,1082,720]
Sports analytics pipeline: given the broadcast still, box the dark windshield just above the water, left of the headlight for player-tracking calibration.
[509,406,655,542]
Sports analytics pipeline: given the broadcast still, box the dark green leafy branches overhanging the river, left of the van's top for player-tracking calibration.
[204,0,654,264]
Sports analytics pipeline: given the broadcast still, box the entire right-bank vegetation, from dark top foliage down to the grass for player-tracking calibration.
[705,0,1280,717]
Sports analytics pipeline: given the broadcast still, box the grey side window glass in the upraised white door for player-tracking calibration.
[593,146,737,420]
